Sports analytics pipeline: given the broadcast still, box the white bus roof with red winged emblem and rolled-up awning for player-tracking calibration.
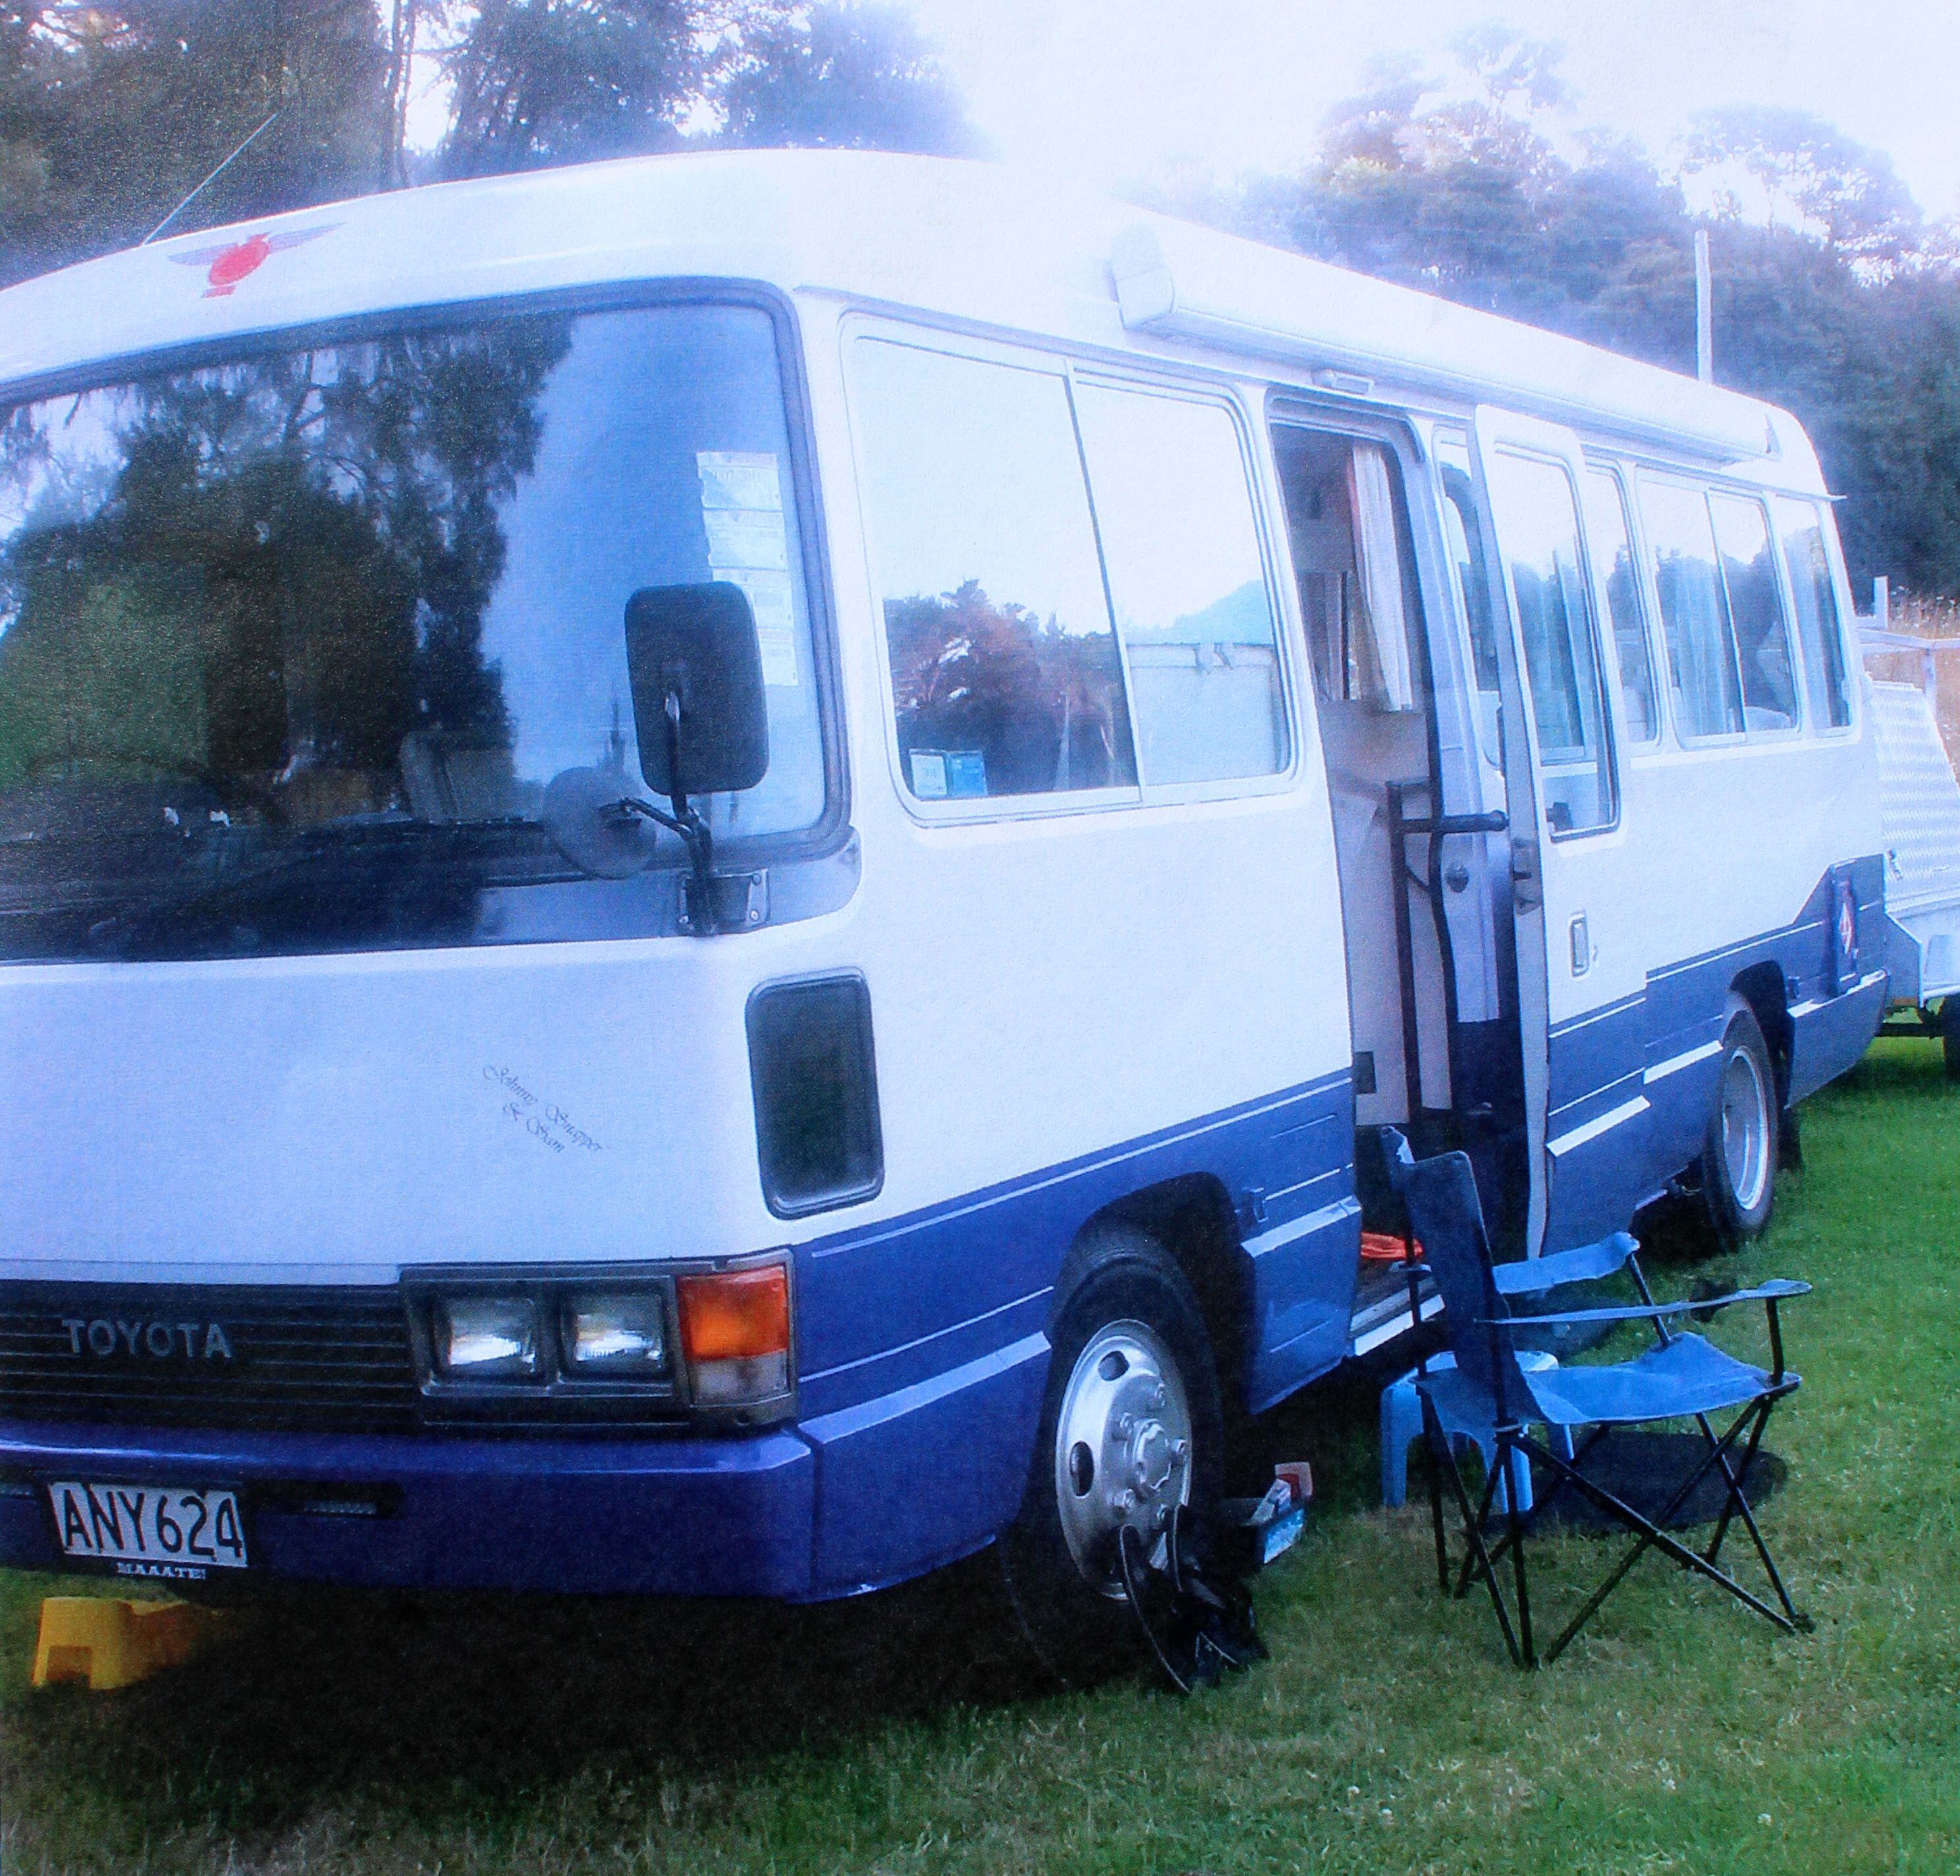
[0,151,1819,486]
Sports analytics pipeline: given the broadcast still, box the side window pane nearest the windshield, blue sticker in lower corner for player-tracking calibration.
[857,339,1137,800]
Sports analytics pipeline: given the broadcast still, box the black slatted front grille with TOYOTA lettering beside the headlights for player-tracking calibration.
[0,1284,420,1433]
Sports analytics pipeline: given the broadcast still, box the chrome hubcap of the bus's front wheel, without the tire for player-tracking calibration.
[1054,1321,1191,1597]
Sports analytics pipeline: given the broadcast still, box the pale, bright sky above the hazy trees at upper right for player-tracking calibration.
[906,0,1960,217]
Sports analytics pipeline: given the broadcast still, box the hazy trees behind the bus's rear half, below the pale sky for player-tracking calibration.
[1207,58,1960,592]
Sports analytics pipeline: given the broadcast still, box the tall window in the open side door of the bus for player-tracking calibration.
[1490,451,1613,833]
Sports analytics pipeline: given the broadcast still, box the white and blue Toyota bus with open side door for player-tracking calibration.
[0,153,1886,1665]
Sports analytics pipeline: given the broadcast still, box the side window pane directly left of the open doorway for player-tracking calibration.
[1076,386,1288,784]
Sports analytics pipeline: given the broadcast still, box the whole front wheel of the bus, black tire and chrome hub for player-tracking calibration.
[1000,1229,1223,1684]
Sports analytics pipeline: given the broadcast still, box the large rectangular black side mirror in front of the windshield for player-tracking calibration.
[625,580,769,812]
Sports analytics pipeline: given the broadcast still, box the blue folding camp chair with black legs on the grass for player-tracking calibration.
[1384,1129,1811,1669]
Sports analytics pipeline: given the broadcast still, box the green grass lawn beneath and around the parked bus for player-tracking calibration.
[0,1043,1960,1876]
